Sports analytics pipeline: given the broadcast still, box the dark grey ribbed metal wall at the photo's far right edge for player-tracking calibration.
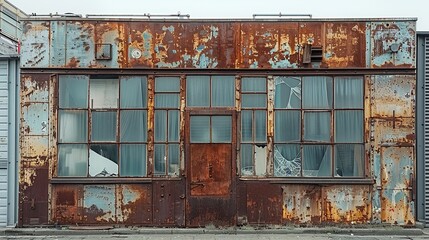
[423,37,429,224]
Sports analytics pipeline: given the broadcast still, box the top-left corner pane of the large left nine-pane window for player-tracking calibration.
[59,75,89,108]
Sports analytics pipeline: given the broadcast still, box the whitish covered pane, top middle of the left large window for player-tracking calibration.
[89,79,119,108]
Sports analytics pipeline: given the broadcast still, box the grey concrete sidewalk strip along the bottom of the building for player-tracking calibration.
[0,226,429,236]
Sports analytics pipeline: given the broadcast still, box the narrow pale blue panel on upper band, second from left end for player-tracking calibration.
[49,21,69,67]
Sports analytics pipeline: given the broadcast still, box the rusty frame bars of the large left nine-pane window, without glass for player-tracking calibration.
[54,74,149,178]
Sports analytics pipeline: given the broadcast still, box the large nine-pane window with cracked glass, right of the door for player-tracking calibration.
[274,76,365,177]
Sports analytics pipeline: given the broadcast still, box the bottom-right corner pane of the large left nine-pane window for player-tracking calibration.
[121,144,146,177]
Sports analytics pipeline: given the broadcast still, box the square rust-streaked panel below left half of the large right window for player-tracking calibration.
[282,185,322,224]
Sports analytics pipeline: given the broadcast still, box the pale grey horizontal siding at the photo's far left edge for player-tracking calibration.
[0,60,9,226]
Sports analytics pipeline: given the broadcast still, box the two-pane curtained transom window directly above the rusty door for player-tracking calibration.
[186,75,235,108]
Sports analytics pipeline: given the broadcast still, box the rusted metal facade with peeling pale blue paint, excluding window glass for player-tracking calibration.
[19,17,416,227]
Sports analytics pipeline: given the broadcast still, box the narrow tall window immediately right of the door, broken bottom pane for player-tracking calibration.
[240,77,267,176]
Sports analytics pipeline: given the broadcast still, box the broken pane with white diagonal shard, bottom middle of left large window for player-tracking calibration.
[89,144,118,177]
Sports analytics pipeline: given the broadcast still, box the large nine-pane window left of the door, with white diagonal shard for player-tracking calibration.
[57,75,147,177]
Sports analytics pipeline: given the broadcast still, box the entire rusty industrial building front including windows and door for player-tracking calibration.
[18,15,416,227]
